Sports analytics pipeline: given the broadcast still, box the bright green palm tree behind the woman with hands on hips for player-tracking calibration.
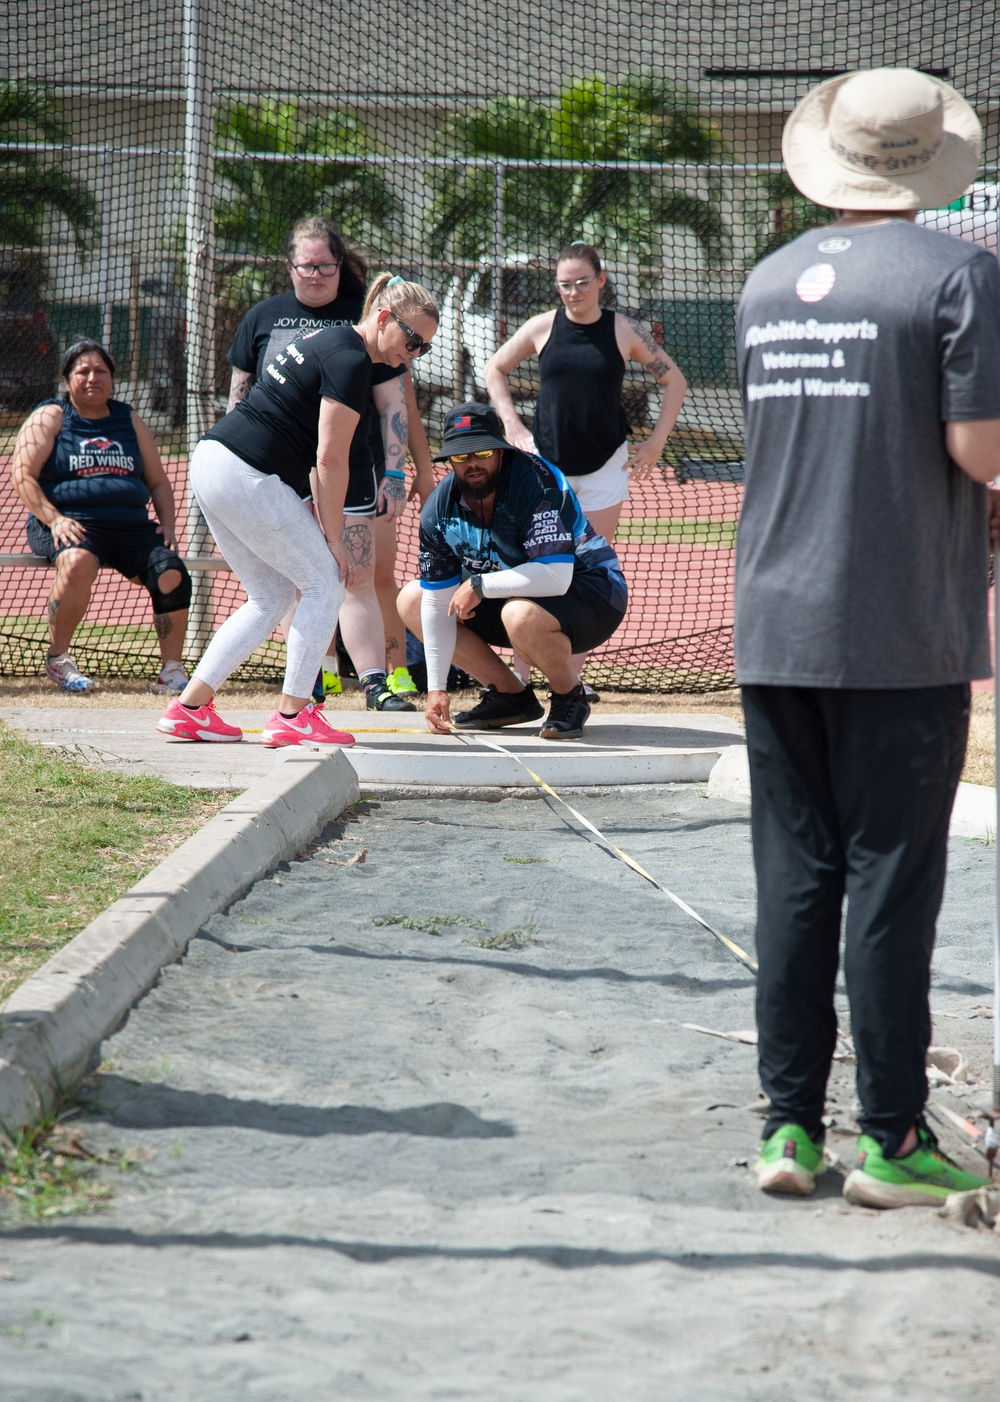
[426,73,722,261]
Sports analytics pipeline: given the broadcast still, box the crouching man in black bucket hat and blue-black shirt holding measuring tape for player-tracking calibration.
[400,404,628,740]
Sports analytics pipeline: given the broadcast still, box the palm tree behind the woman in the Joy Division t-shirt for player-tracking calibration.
[216,98,400,307]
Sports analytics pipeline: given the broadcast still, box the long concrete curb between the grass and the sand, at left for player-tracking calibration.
[0,750,359,1126]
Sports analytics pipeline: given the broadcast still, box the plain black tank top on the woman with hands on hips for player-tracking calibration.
[532,307,628,477]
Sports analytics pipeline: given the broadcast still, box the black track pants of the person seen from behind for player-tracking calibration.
[742,684,969,1152]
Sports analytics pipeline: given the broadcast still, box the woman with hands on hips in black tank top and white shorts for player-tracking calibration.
[485,243,687,695]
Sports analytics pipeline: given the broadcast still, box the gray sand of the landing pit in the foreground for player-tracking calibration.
[0,787,1000,1402]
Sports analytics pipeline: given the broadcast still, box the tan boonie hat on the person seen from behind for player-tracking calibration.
[781,69,983,209]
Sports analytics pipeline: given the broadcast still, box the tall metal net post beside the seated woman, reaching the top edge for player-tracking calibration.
[184,0,215,659]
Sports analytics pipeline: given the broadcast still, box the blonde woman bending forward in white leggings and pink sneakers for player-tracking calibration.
[157,273,438,749]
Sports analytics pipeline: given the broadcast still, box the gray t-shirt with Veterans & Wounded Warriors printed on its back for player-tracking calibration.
[736,220,1000,688]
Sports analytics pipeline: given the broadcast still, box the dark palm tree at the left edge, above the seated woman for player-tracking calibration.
[0,80,98,254]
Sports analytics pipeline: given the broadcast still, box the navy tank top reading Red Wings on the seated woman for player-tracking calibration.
[38,400,150,522]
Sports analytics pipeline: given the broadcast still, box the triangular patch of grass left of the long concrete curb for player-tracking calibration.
[0,725,231,998]
